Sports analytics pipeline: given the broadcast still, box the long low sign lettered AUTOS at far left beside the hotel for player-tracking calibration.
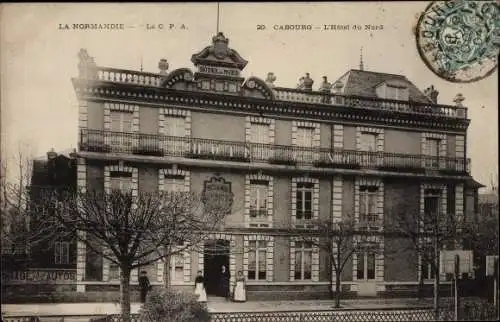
[2,269,76,284]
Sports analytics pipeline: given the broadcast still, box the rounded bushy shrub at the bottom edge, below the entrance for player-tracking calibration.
[139,289,210,322]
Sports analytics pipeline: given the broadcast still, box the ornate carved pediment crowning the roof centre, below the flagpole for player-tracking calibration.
[191,32,248,71]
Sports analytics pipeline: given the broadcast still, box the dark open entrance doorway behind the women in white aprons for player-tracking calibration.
[203,239,229,296]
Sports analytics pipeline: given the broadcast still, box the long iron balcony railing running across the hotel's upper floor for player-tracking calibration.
[80,130,470,173]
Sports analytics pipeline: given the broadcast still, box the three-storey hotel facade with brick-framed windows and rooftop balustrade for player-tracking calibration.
[73,33,476,299]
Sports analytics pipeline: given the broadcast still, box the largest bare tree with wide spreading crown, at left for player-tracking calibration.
[44,190,232,322]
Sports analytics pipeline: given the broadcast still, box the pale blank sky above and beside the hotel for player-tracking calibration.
[0,1,498,186]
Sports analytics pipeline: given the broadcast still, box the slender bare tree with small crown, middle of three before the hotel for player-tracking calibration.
[297,217,369,307]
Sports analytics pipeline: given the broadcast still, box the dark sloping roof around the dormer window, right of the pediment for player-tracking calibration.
[339,69,432,103]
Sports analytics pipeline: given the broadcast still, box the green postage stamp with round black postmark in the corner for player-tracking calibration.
[415,0,500,83]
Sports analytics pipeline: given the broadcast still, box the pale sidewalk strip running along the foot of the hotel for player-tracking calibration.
[2,298,445,316]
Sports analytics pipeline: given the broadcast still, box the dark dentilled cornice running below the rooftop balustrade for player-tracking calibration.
[72,78,470,132]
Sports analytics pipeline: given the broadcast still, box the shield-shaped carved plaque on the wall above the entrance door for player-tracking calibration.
[202,173,234,214]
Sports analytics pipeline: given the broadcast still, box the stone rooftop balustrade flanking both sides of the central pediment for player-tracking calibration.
[91,67,467,119]
